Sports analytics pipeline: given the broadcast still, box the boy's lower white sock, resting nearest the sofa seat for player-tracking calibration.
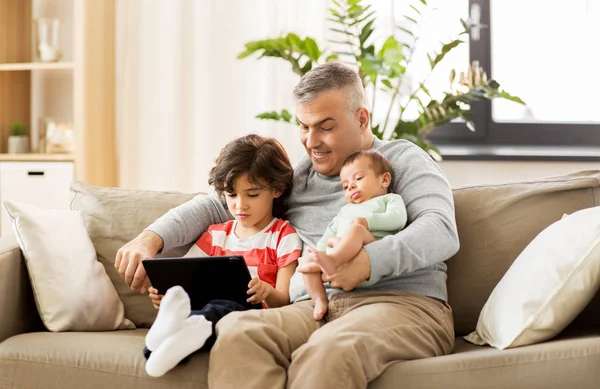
[146,316,212,377]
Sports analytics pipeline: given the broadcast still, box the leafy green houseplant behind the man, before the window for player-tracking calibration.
[238,0,524,159]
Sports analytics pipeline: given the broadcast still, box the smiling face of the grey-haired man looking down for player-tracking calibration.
[296,90,371,176]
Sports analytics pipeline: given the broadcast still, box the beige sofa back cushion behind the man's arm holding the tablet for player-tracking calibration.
[71,182,202,328]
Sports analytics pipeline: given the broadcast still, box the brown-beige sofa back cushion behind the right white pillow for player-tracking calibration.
[447,170,600,336]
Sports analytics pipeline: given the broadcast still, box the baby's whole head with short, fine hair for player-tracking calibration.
[340,149,393,204]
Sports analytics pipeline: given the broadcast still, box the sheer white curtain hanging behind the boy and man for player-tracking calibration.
[116,0,329,192]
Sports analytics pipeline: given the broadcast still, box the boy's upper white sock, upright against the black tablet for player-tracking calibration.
[146,286,191,351]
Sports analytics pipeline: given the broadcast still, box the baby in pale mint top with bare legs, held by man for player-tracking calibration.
[303,149,407,320]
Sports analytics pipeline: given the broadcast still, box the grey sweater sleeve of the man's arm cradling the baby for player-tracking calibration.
[365,146,459,283]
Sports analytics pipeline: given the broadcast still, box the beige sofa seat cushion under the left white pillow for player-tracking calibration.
[0,329,208,389]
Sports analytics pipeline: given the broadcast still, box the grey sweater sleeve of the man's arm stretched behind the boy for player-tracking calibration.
[146,193,232,251]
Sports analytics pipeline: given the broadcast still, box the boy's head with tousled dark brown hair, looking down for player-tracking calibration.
[208,134,293,221]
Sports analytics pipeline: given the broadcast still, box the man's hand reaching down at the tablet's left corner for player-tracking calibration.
[115,231,163,294]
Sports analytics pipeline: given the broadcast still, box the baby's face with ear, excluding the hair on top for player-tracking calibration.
[340,156,392,204]
